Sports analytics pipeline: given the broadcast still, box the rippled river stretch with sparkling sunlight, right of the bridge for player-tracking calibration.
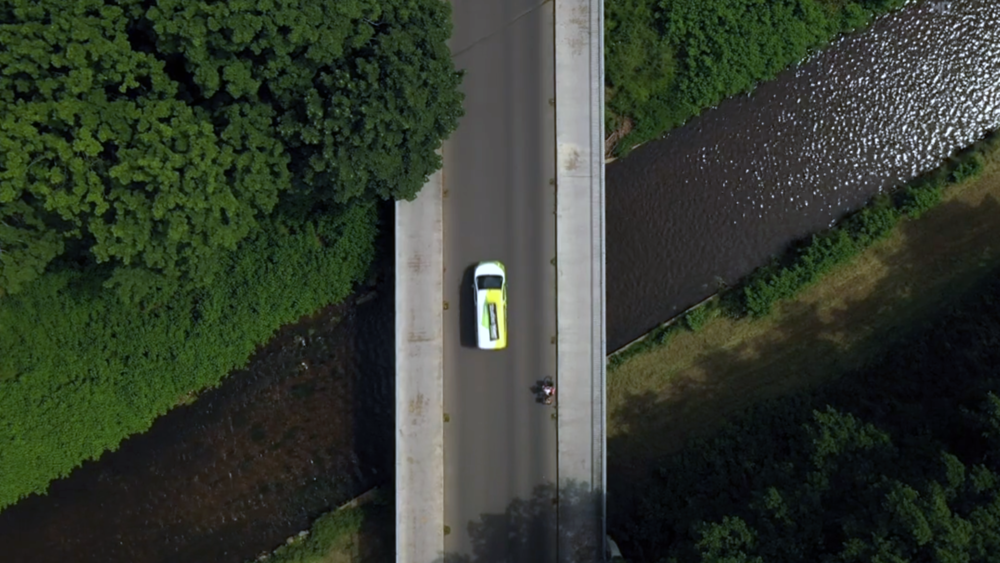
[606,0,1000,351]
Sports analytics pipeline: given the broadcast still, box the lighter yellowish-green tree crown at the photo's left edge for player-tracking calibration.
[0,0,288,298]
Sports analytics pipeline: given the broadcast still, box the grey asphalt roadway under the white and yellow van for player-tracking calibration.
[444,0,558,563]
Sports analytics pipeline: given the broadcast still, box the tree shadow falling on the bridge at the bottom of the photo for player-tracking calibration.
[434,481,603,563]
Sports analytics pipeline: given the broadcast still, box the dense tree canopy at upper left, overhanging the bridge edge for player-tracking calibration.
[0,0,462,293]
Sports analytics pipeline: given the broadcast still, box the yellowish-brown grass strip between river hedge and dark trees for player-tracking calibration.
[608,149,1000,479]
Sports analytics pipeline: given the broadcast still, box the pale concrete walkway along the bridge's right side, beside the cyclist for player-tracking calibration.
[555,0,607,563]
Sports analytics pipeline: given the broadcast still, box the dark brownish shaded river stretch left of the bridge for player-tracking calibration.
[0,235,395,563]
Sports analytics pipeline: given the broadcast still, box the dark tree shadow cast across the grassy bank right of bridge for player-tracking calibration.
[607,195,1000,561]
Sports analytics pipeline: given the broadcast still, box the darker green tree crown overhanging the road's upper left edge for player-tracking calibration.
[147,0,462,203]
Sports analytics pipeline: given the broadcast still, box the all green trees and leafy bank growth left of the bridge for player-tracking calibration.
[0,0,462,509]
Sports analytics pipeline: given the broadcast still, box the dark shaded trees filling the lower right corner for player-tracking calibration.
[609,268,1000,563]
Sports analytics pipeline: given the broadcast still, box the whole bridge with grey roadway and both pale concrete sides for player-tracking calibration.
[395,0,606,563]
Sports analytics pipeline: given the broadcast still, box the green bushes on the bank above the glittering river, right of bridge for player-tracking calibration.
[604,0,905,158]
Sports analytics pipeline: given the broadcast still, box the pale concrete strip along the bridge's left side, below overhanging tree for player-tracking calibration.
[395,158,444,563]
